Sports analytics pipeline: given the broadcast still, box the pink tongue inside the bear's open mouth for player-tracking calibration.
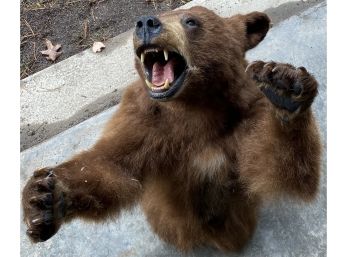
[151,60,174,87]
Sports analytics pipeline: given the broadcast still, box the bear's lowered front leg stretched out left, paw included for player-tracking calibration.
[22,146,141,242]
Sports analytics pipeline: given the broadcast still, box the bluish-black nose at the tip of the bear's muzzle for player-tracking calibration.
[135,16,162,44]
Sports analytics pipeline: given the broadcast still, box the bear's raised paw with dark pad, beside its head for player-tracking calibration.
[246,61,318,124]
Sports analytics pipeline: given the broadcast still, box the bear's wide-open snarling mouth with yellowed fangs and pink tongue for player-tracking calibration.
[136,45,187,100]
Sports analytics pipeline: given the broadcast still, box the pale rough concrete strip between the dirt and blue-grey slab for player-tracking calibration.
[20,0,322,150]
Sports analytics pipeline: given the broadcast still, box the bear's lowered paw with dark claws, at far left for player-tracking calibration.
[22,168,66,243]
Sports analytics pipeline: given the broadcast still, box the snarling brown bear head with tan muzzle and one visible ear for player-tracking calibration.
[133,7,270,101]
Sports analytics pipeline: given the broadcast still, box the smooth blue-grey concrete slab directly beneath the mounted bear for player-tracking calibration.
[20,3,326,257]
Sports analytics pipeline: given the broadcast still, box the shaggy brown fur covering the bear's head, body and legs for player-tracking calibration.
[23,7,320,251]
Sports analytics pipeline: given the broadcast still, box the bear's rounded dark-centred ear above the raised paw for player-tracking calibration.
[231,12,271,51]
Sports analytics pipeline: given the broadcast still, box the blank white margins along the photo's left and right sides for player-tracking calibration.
[0,0,348,257]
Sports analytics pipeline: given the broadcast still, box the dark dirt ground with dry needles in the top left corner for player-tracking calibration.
[20,0,190,79]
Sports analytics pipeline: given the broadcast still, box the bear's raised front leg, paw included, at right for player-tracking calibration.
[240,61,321,200]
